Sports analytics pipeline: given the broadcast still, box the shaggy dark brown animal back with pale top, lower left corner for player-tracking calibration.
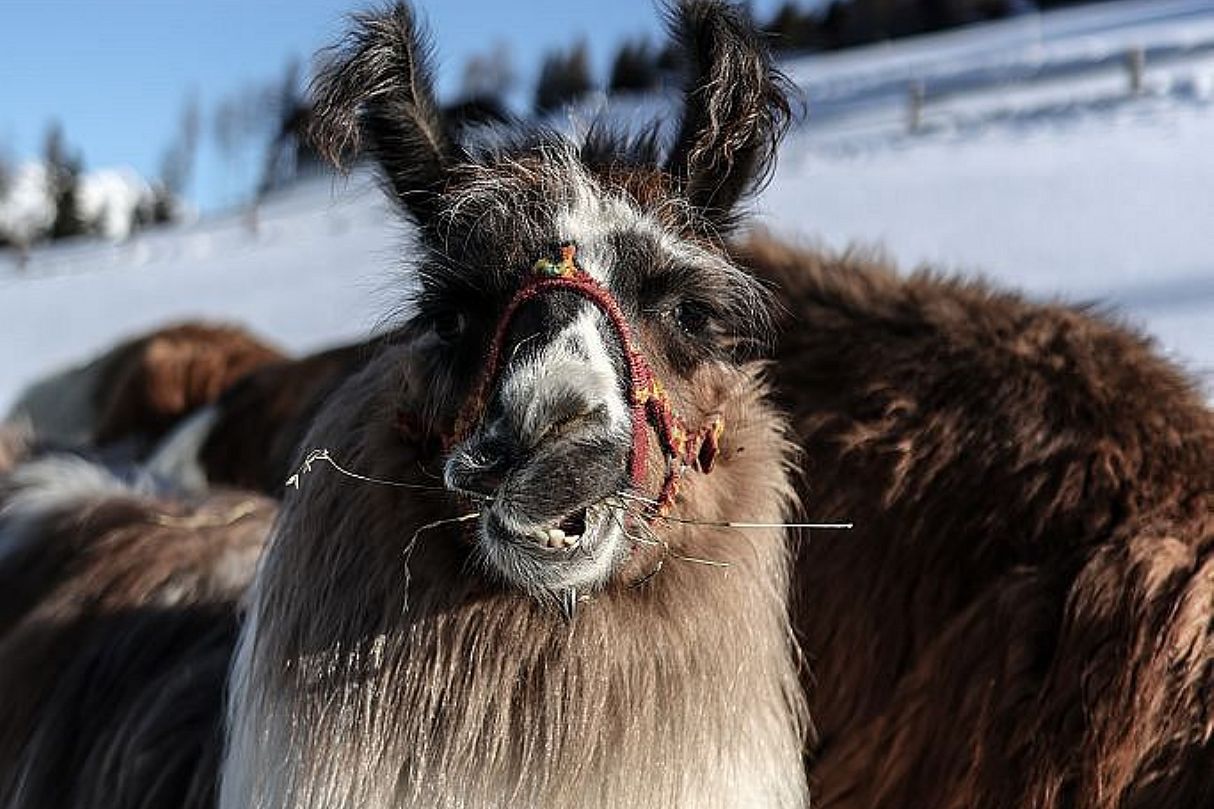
[0,458,274,809]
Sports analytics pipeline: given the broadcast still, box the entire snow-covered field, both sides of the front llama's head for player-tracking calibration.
[0,0,1214,411]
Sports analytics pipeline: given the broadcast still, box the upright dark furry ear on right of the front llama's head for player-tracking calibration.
[666,0,790,224]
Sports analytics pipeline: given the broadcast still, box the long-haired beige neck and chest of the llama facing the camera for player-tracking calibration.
[221,357,806,809]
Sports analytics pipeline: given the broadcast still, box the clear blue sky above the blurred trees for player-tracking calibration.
[0,0,791,209]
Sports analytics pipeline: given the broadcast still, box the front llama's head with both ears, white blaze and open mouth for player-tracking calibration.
[314,0,789,594]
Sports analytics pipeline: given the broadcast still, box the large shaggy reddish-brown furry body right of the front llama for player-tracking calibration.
[739,236,1214,809]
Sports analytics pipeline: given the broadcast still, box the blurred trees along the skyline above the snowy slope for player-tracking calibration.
[0,0,1121,253]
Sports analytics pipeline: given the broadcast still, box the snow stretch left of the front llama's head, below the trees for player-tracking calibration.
[0,172,402,412]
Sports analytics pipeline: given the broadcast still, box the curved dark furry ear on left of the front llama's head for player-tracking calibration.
[310,4,456,222]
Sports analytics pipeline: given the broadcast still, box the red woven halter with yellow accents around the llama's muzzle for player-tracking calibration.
[452,244,725,515]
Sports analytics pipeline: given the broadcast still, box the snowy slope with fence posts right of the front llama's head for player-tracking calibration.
[759,0,1214,392]
